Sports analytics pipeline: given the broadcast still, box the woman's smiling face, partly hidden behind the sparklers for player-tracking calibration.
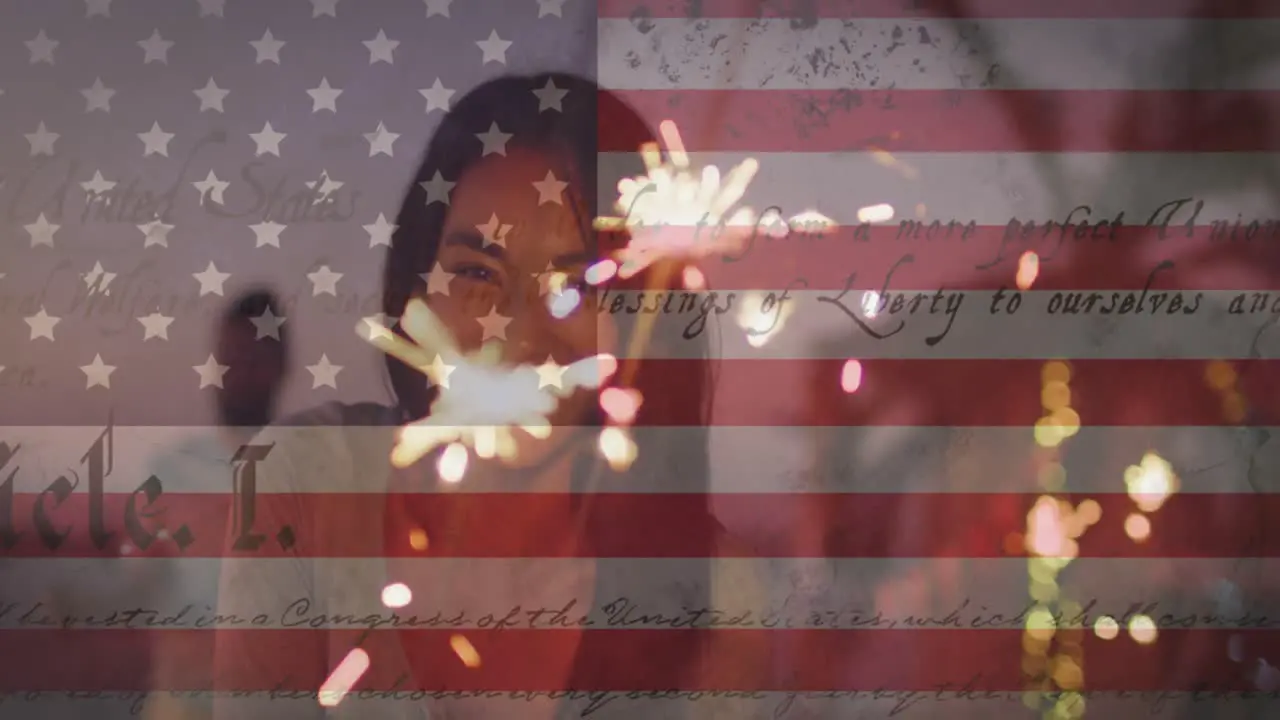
[428,147,617,434]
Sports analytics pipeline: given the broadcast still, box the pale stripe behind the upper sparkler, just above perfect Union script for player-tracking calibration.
[598,152,1280,225]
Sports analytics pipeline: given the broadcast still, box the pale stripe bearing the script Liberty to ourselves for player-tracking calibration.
[600,288,1280,361]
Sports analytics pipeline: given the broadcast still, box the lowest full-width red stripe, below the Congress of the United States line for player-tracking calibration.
[0,628,1280,700]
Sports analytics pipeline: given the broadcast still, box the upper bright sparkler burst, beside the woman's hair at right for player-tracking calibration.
[594,120,760,279]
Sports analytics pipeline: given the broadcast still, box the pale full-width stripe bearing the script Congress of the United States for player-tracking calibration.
[0,558,1280,630]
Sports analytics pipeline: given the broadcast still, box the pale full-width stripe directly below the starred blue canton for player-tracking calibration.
[3,425,1280,491]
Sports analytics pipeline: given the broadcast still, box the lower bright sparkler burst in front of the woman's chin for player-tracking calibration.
[360,299,617,466]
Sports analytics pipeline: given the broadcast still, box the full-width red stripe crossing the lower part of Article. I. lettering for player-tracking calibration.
[10,489,1280,559]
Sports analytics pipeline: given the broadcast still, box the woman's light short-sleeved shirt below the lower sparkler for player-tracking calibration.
[208,404,758,720]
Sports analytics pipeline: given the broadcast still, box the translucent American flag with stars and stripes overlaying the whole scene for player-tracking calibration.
[0,0,1280,720]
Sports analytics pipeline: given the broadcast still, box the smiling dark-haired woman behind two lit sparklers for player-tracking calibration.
[207,74,747,720]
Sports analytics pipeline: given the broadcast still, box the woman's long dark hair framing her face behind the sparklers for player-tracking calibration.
[383,73,714,671]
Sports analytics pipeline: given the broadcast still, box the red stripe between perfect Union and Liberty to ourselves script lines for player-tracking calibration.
[701,225,1280,289]
